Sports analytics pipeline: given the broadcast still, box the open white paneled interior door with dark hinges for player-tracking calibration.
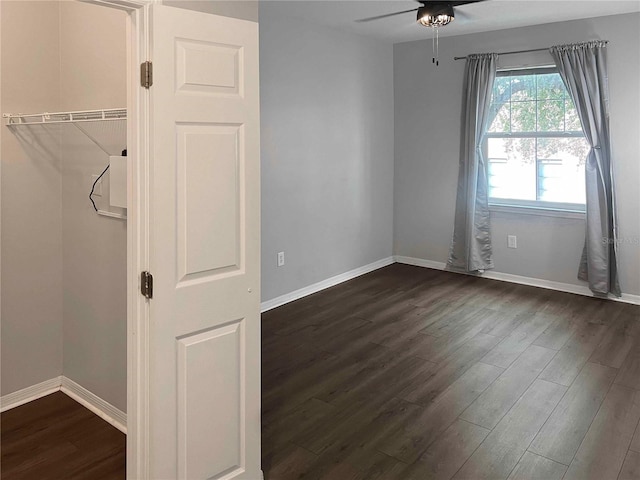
[148,4,261,480]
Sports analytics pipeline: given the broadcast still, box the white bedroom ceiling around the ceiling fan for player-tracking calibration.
[260,0,640,43]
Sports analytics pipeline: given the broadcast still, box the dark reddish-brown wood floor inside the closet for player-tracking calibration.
[0,392,126,480]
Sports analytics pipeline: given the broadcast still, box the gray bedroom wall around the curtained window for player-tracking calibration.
[394,14,640,295]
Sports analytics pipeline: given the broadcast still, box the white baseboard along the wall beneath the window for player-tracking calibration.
[394,255,640,305]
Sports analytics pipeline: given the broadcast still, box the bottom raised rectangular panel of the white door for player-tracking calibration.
[177,320,244,480]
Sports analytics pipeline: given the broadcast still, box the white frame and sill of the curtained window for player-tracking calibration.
[481,65,586,217]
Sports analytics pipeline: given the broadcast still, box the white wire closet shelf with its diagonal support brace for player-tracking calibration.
[2,108,127,220]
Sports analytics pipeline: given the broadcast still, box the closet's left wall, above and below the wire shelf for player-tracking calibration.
[0,2,62,395]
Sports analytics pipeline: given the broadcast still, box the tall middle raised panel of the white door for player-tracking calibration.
[176,124,245,282]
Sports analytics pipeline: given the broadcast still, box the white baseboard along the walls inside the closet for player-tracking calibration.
[0,375,127,433]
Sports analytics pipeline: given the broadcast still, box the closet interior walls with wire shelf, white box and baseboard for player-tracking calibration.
[0,1,127,438]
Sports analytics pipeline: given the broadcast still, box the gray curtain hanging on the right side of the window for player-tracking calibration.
[550,41,620,296]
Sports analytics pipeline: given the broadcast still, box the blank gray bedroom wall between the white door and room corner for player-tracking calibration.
[260,2,393,301]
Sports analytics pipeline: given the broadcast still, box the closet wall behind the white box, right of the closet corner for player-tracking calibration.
[60,2,127,411]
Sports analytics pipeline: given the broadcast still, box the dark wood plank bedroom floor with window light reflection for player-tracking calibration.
[262,264,640,480]
